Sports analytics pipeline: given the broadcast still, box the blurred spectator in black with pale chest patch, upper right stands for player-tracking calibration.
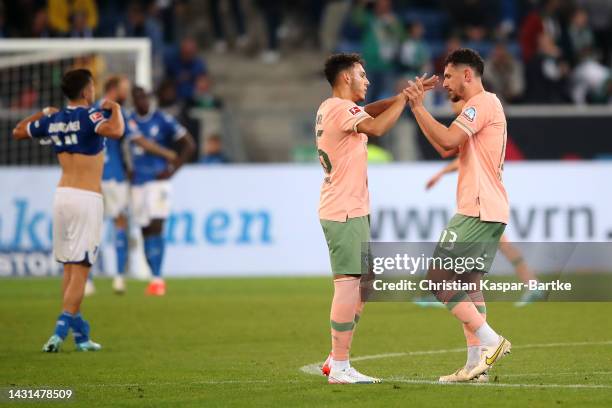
[525,32,569,103]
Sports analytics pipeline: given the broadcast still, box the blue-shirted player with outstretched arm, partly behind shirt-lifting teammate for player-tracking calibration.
[95,75,176,294]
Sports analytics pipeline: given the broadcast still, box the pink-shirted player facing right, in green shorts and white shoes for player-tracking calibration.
[315,54,435,384]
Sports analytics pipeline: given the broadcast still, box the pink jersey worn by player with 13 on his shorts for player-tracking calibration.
[453,92,510,224]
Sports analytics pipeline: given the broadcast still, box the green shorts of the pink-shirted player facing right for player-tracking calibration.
[321,215,370,275]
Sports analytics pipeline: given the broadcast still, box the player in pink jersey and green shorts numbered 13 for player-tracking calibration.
[406,48,511,382]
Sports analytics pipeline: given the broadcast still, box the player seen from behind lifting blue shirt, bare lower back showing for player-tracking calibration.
[13,69,124,352]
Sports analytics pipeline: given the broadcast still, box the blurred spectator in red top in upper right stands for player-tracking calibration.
[519,0,561,63]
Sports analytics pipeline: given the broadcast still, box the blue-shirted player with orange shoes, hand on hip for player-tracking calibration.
[130,87,195,296]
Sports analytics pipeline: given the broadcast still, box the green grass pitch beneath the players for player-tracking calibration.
[0,278,612,407]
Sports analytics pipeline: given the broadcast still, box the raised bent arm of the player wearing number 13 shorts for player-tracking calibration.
[405,79,468,151]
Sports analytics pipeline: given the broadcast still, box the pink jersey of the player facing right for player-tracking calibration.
[315,98,370,222]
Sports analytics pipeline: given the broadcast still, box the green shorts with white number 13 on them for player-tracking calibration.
[434,214,506,273]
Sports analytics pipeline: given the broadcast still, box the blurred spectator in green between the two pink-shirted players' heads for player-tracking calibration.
[361,0,404,100]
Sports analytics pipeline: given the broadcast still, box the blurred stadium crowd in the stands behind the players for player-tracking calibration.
[0,0,612,108]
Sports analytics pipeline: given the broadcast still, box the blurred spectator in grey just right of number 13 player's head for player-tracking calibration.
[484,43,525,103]
